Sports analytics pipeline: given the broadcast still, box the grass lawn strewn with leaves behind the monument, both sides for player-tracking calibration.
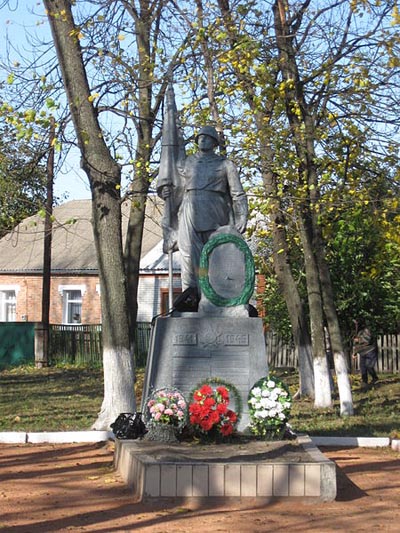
[0,367,400,438]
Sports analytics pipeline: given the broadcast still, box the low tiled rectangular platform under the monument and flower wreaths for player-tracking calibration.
[115,437,336,501]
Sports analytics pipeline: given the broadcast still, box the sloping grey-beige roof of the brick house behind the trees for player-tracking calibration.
[0,196,170,274]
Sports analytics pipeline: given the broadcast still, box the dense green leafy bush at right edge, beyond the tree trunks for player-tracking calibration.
[321,157,400,342]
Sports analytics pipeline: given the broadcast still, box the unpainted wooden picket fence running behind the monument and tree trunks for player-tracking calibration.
[50,322,400,373]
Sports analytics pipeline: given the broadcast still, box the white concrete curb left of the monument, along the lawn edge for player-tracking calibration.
[0,431,114,444]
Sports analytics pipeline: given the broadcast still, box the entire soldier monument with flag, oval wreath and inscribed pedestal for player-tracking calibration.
[142,84,268,431]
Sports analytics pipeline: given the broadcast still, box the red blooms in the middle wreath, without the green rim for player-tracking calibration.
[189,383,238,437]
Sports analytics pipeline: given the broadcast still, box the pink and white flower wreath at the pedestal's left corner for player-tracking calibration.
[145,387,187,430]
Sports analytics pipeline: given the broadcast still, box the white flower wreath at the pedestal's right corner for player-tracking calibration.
[248,375,292,439]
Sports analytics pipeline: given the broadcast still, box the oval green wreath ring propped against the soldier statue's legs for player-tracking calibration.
[199,233,255,307]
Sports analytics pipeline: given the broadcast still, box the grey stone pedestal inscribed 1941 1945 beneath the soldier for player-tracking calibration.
[142,313,268,431]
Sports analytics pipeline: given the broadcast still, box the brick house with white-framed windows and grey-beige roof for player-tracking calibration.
[0,197,180,324]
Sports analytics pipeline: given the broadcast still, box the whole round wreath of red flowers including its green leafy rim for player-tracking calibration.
[189,378,242,440]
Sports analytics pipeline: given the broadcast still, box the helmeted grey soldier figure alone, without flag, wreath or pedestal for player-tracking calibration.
[157,118,248,290]
